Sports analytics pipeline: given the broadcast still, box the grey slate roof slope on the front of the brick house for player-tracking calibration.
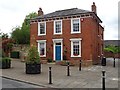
[36,8,91,19]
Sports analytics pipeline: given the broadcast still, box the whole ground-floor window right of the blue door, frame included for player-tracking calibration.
[70,39,81,57]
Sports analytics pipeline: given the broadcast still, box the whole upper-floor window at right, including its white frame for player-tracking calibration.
[71,18,80,33]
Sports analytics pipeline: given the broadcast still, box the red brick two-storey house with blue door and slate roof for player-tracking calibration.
[30,3,104,64]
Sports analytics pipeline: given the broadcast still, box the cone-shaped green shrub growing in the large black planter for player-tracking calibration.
[26,46,40,64]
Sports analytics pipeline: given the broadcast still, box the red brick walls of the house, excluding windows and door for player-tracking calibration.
[30,17,103,64]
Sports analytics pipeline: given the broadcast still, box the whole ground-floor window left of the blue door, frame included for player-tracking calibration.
[38,40,46,57]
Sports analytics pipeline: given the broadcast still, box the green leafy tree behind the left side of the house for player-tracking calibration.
[11,12,38,44]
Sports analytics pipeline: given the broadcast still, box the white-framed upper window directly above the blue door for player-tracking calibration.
[54,20,62,34]
